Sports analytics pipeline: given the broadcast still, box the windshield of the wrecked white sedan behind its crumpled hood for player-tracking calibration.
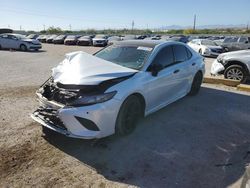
[95,45,152,70]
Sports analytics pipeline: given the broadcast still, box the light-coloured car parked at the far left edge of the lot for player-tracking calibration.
[0,33,42,51]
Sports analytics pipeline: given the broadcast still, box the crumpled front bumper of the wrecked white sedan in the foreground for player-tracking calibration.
[31,94,121,139]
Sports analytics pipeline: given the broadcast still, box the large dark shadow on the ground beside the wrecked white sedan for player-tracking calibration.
[44,87,250,187]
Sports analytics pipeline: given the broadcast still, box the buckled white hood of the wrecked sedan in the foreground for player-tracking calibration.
[52,51,138,85]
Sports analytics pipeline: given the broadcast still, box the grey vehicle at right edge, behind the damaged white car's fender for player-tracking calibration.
[221,36,250,52]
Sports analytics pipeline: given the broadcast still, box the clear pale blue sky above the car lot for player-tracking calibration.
[0,0,250,31]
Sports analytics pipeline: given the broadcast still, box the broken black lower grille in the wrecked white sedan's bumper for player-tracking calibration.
[34,107,67,130]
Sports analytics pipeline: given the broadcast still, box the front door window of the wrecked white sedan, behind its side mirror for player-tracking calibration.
[153,46,174,67]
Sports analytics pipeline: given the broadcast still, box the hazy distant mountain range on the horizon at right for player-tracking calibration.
[158,24,246,30]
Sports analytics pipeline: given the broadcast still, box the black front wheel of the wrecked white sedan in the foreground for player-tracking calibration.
[115,95,143,135]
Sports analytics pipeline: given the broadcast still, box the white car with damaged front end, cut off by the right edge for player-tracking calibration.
[211,50,250,83]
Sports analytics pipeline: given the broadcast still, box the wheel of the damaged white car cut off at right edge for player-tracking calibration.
[224,65,247,83]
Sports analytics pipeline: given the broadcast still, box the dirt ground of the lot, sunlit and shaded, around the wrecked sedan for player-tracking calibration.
[0,45,250,187]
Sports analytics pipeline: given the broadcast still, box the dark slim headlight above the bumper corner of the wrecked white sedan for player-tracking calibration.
[67,91,117,106]
